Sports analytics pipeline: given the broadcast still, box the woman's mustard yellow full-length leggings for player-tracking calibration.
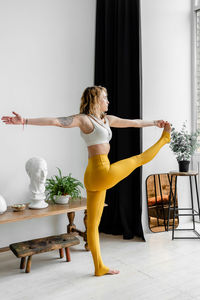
[84,131,170,276]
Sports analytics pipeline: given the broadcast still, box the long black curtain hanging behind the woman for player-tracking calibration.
[95,0,144,240]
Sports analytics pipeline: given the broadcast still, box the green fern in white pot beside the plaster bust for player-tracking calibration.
[46,168,83,204]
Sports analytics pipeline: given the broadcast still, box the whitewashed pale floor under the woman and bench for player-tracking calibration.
[0,224,200,300]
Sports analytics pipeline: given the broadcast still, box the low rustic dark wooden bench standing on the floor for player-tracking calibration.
[9,234,80,273]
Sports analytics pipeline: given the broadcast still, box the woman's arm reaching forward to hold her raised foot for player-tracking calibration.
[107,115,166,128]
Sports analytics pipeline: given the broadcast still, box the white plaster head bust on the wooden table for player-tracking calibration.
[25,157,48,209]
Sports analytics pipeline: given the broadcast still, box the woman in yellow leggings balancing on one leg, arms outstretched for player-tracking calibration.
[2,86,171,276]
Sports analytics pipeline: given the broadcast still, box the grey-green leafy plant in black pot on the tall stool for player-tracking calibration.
[170,122,200,172]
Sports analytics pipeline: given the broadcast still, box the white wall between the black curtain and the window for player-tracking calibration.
[141,0,191,231]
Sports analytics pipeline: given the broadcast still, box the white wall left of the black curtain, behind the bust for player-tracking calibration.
[0,0,96,247]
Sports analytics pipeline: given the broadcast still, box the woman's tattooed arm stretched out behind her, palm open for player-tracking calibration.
[1,111,80,128]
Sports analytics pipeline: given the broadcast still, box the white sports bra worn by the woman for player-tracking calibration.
[80,115,112,146]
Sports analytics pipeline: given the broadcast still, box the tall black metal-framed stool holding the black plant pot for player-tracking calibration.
[167,171,200,240]
